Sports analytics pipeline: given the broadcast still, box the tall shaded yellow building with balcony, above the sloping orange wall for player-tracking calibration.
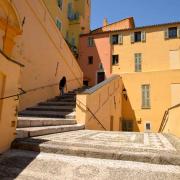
[43,0,91,51]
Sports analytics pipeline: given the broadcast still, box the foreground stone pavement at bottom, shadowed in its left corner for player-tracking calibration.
[0,150,180,180]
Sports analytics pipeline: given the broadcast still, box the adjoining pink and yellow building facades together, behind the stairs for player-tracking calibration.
[79,18,180,132]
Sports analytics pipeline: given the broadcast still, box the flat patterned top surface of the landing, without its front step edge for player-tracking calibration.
[26,130,176,153]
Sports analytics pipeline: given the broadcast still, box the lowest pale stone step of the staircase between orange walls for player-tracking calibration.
[16,124,85,138]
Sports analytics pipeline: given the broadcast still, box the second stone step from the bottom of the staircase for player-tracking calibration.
[17,117,76,128]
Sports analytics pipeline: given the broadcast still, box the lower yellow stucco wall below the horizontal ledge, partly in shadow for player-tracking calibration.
[121,70,180,132]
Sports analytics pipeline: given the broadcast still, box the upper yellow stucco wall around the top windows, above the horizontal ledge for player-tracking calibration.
[112,24,180,73]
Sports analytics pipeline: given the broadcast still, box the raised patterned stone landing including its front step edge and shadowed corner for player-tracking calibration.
[14,130,180,165]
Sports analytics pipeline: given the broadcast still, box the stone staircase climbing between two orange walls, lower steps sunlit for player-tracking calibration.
[17,88,85,138]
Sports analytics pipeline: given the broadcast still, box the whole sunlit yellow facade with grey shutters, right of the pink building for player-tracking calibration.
[111,23,180,132]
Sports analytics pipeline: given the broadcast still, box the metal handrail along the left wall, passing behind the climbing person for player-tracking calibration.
[0,78,81,101]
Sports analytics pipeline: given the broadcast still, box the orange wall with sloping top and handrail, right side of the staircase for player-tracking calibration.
[76,76,122,131]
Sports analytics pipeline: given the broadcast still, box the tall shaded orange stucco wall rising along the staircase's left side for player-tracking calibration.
[13,0,83,110]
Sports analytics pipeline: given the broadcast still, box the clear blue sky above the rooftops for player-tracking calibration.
[91,0,180,30]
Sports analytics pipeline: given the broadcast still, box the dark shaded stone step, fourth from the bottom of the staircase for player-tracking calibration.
[27,106,75,112]
